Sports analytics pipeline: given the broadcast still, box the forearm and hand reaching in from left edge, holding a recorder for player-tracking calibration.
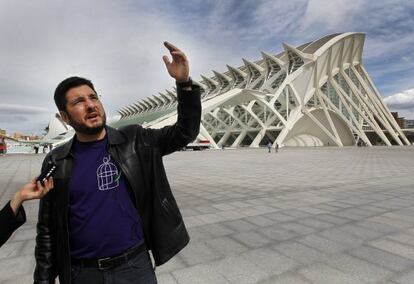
[0,178,53,247]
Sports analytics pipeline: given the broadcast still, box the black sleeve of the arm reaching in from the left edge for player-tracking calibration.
[0,202,26,247]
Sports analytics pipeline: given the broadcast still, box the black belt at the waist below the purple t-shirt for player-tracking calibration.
[72,243,146,270]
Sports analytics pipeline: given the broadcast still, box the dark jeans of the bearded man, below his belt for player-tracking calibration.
[71,251,157,284]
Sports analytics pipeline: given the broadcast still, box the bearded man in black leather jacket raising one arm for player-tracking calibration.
[34,42,201,284]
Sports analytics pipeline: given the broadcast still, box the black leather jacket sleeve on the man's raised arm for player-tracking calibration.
[144,84,201,155]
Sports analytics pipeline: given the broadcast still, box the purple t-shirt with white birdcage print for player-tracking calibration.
[69,137,144,259]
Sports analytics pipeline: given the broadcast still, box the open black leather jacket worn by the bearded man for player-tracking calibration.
[34,85,201,284]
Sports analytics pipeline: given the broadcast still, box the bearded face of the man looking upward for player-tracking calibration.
[61,85,106,135]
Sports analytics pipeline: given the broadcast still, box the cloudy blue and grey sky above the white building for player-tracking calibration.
[0,0,414,134]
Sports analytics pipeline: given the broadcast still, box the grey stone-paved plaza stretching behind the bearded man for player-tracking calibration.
[0,147,414,284]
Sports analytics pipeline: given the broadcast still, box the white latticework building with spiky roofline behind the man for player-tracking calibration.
[113,33,410,147]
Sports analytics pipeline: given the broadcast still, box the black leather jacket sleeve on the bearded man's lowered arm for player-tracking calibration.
[34,157,57,284]
